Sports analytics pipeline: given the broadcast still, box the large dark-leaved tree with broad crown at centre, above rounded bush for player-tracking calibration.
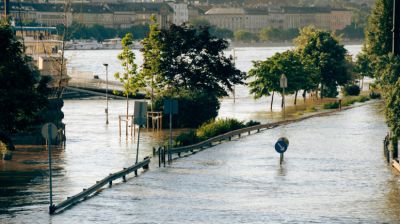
[157,25,245,97]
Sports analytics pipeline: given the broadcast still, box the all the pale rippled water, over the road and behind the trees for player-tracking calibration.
[0,46,400,223]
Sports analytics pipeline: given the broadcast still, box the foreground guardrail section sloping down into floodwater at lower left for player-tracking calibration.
[49,157,150,214]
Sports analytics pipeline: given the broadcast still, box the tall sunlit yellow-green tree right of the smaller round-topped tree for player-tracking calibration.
[295,27,351,98]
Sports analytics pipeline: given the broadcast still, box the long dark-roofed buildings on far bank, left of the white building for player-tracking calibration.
[0,3,174,28]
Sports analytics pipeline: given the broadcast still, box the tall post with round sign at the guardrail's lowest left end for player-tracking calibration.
[42,123,57,214]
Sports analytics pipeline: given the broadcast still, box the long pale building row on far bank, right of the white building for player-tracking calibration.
[202,7,352,33]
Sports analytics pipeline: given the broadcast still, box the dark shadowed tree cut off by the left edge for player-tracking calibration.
[0,23,48,135]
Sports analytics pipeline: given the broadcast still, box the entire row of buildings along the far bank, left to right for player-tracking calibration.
[4,2,352,33]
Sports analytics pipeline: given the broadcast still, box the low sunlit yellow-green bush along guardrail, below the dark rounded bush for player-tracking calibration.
[196,118,245,140]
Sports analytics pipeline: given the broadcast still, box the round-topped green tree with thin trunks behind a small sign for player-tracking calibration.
[248,50,312,110]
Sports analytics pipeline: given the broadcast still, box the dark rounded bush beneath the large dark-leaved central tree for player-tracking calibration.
[154,92,220,128]
